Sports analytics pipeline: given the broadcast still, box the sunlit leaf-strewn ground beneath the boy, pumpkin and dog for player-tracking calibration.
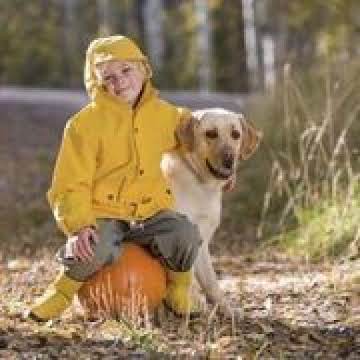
[0,252,360,359]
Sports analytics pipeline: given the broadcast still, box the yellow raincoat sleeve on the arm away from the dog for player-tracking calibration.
[47,112,98,235]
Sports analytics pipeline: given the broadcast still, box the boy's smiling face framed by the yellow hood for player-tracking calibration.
[96,60,145,105]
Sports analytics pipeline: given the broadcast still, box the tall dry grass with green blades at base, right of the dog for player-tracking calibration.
[250,60,360,259]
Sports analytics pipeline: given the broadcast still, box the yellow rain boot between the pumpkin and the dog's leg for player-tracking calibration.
[165,269,196,316]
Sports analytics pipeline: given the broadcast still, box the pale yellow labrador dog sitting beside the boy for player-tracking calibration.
[161,108,260,316]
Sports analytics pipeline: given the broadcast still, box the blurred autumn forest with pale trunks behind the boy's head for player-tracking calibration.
[0,0,360,92]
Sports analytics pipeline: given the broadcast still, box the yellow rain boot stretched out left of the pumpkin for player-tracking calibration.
[28,273,83,321]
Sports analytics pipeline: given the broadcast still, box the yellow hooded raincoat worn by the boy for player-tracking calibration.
[48,36,189,235]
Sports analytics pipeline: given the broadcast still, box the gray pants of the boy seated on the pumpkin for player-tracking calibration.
[56,210,202,281]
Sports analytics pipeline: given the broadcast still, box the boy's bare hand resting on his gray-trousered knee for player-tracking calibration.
[66,226,99,261]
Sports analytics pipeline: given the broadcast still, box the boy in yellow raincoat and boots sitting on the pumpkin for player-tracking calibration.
[29,36,201,321]
